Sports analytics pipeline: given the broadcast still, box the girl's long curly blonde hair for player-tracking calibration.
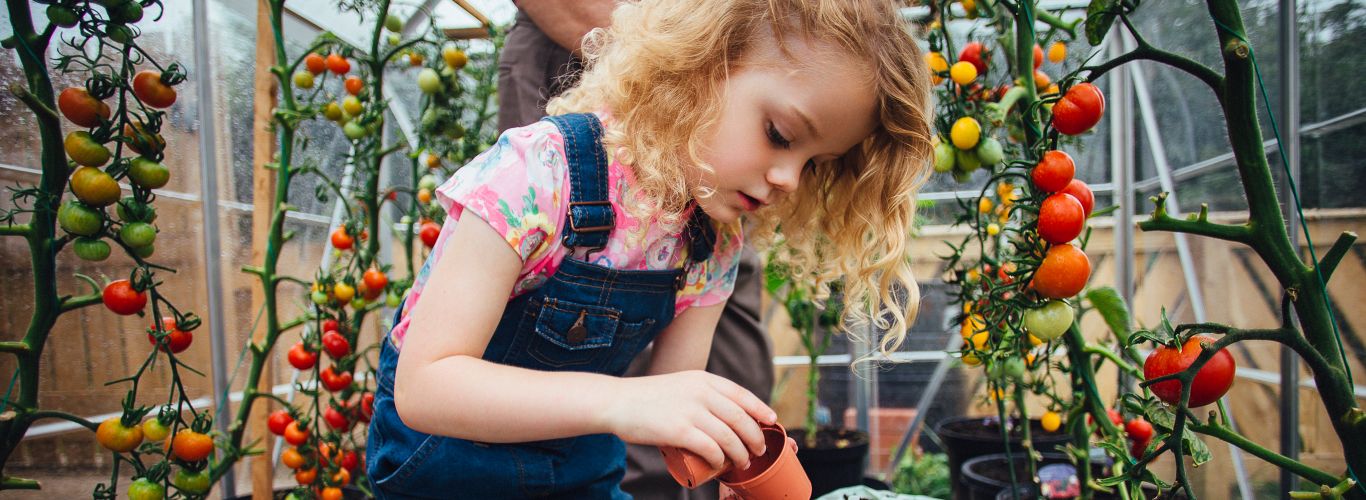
[546,0,932,352]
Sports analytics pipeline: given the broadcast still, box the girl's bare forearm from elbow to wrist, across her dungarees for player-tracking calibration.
[393,355,623,443]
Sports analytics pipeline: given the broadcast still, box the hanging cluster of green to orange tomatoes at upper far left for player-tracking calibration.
[57,70,184,261]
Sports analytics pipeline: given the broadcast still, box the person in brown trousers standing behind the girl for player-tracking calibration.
[499,0,773,500]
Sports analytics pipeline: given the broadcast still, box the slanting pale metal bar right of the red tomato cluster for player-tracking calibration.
[1126,54,1253,500]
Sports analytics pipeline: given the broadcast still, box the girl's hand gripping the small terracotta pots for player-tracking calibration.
[602,370,777,469]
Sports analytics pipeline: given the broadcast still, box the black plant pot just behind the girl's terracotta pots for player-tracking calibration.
[787,428,869,499]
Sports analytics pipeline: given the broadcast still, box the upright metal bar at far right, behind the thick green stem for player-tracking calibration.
[1277,0,1300,500]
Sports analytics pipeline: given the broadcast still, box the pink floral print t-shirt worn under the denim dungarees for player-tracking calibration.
[389,117,742,347]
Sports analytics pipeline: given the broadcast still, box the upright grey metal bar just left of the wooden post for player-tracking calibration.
[193,0,236,499]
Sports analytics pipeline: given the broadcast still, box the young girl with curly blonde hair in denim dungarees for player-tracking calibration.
[367,0,930,499]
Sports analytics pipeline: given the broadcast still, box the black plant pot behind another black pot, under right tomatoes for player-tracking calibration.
[934,417,1071,499]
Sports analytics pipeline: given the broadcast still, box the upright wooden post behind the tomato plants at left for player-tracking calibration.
[245,0,279,500]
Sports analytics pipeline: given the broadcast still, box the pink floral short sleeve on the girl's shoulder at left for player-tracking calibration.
[436,122,568,269]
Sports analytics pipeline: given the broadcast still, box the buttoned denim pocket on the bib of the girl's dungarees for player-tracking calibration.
[527,298,622,370]
